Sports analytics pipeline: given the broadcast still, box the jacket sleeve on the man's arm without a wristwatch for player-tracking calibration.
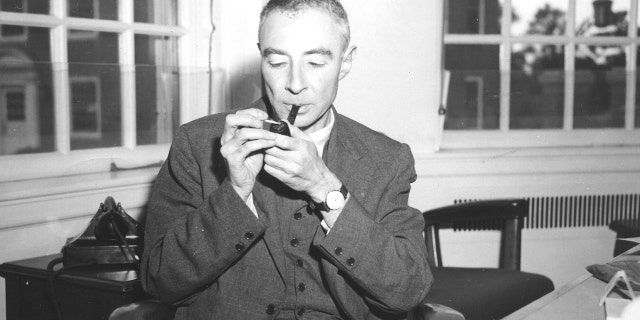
[140,128,266,305]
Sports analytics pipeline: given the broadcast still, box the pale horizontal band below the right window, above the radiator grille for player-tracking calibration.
[415,146,640,177]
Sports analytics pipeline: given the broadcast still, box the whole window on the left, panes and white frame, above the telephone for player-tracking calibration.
[0,0,205,182]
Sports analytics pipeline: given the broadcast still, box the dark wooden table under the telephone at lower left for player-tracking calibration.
[0,254,148,320]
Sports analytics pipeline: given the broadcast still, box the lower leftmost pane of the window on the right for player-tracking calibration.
[445,45,500,130]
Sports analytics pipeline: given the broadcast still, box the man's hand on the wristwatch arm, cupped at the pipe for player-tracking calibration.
[264,123,341,202]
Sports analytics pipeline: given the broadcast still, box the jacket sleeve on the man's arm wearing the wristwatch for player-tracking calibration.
[314,145,433,313]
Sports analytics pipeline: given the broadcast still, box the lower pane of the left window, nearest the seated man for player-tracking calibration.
[135,34,179,145]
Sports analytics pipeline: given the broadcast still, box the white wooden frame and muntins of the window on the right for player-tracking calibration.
[440,0,640,149]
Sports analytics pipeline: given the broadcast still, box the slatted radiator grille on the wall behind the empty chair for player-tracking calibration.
[454,194,640,229]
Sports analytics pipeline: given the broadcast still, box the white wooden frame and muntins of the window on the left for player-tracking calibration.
[0,0,210,183]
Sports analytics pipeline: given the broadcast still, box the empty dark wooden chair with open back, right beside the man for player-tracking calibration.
[415,199,554,320]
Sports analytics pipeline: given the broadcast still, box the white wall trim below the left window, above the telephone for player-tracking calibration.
[0,167,158,231]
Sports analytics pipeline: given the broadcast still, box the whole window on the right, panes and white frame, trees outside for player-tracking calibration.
[443,0,640,148]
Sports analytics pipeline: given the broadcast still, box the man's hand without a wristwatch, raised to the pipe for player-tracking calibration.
[220,109,277,201]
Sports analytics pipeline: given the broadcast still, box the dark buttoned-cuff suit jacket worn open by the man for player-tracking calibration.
[141,101,433,319]
